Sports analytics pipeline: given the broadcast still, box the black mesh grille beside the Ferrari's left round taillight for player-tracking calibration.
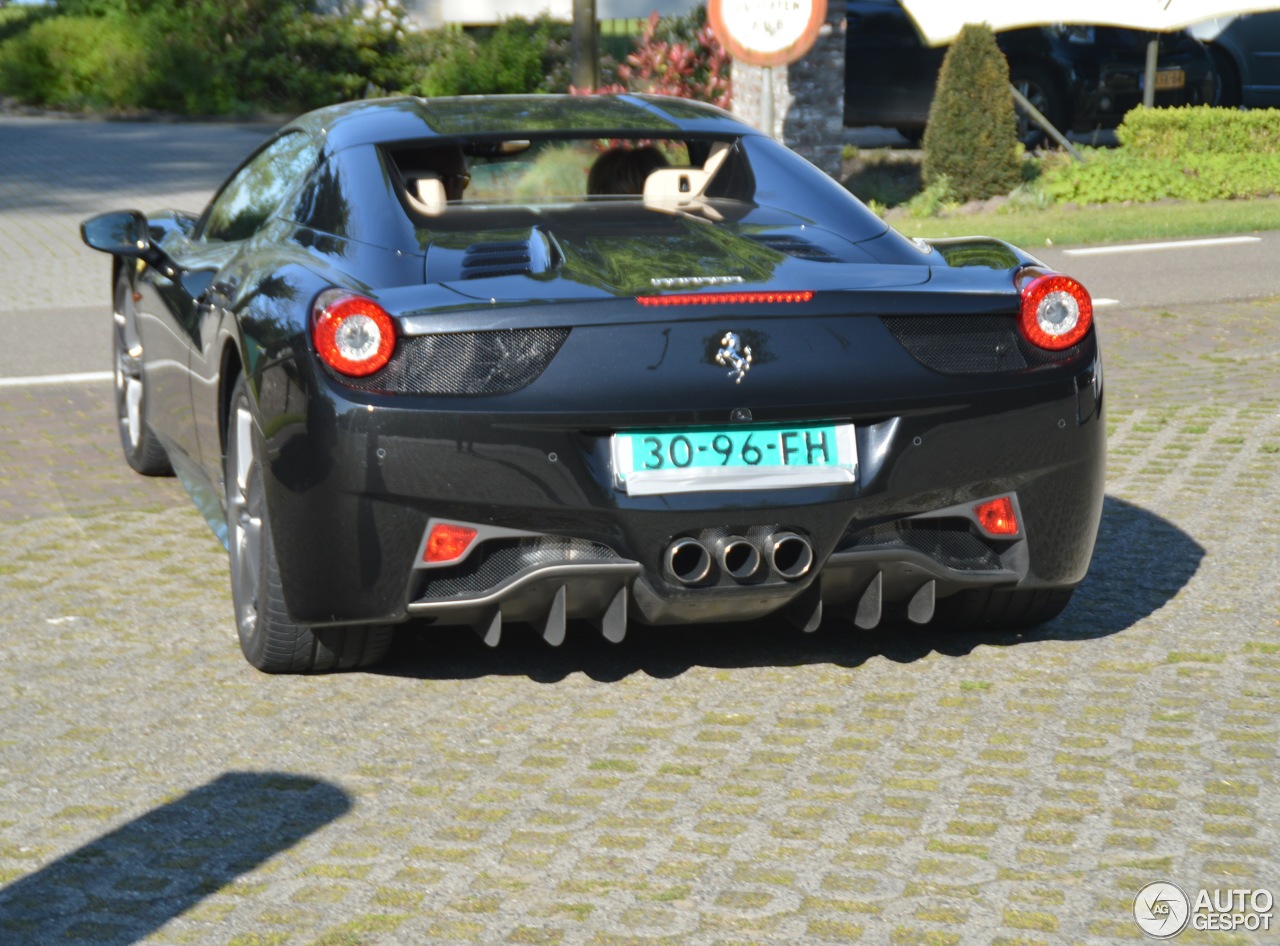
[340,329,570,394]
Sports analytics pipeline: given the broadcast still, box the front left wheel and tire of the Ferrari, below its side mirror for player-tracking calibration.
[111,270,173,476]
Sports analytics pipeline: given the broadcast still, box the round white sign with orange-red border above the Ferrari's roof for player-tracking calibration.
[707,0,827,65]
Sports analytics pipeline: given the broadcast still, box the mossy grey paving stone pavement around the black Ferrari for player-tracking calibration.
[0,114,1280,946]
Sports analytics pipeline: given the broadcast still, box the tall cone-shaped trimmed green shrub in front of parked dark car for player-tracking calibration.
[924,24,1021,201]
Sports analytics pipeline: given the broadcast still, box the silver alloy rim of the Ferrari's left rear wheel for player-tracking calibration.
[227,394,262,640]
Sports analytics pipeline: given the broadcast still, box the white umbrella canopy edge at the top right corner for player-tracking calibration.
[901,0,1280,46]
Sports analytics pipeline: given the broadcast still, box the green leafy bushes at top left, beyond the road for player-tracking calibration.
[0,0,570,115]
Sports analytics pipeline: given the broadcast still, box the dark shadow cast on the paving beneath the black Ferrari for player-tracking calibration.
[376,497,1204,682]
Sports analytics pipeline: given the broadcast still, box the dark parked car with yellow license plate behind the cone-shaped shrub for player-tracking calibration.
[845,0,1213,146]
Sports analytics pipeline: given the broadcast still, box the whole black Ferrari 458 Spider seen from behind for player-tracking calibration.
[83,96,1105,672]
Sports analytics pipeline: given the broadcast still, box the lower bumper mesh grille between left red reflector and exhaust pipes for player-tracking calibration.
[420,535,625,600]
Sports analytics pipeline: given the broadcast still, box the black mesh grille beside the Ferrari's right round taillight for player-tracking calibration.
[881,315,1080,375]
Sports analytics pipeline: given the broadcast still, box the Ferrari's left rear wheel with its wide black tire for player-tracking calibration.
[223,378,394,673]
